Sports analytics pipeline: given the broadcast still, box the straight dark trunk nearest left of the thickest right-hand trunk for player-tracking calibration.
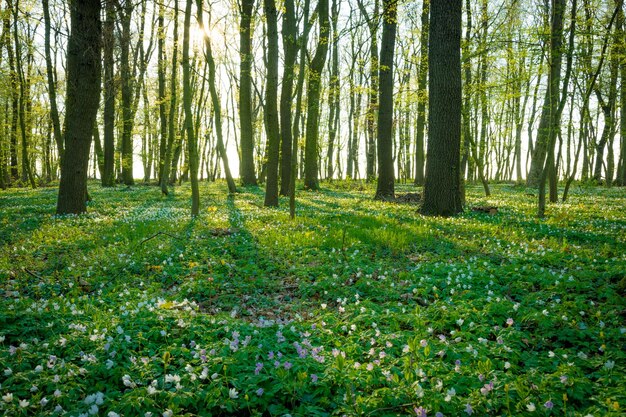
[375,0,398,200]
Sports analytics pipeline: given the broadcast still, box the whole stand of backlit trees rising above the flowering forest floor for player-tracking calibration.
[0,0,626,215]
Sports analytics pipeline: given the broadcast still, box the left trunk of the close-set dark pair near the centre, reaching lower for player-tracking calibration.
[263,0,280,207]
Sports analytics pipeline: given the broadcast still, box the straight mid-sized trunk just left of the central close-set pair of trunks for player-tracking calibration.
[239,0,256,186]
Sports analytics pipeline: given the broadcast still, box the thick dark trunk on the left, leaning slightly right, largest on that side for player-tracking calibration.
[57,0,102,214]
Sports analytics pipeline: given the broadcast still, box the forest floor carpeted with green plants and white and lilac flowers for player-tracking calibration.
[0,182,626,417]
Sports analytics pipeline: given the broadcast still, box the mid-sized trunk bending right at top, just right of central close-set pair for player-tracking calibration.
[304,0,330,190]
